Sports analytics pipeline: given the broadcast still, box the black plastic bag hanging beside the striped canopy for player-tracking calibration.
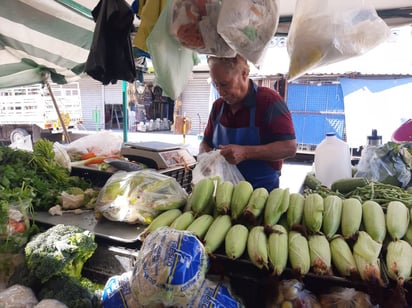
[85,0,136,85]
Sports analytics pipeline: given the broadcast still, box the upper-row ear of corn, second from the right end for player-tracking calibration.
[362,200,386,243]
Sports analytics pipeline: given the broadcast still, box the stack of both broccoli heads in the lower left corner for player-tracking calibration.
[9,224,104,308]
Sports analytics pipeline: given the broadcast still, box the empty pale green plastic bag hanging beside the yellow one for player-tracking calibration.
[146,0,199,100]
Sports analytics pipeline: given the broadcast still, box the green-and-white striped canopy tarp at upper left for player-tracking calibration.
[0,0,95,88]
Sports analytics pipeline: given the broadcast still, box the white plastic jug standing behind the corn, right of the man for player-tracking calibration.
[315,133,352,188]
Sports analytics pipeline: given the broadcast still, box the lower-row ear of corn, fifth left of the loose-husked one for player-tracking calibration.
[247,226,268,269]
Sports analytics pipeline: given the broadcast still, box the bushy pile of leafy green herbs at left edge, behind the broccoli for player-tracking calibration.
[0,139,92,210]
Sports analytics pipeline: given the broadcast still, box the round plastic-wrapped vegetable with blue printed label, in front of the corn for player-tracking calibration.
[132,227,209,306]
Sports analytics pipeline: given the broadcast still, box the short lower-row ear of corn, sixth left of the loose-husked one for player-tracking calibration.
[225,224,249,260]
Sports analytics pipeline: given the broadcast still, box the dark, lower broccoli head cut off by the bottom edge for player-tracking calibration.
[37,275,104,308]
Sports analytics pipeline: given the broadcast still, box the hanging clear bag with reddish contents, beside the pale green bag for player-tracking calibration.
[170,0,236,57]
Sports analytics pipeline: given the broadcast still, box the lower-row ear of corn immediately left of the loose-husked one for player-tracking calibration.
[329,236,358,277]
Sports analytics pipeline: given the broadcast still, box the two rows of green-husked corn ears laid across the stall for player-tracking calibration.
[144,178,412,285]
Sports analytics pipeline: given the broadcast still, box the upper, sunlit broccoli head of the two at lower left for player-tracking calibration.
[25,224,97,283]
